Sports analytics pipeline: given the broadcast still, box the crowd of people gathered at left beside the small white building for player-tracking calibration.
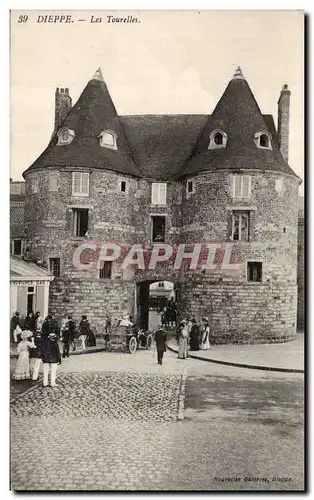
[11,311,96,387]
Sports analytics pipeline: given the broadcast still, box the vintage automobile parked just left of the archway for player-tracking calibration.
[106,325,154,354]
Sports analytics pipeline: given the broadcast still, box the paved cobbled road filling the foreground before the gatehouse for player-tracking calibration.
[11,350,303,490]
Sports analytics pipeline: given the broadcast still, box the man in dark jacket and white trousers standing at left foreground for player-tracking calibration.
[41,332,61,387]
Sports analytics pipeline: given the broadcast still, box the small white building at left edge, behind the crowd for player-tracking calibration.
[10,255,54,319]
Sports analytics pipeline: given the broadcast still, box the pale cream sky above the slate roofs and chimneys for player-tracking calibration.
[11,11,304,192]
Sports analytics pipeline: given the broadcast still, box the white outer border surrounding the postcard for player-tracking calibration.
[0,0,314,499]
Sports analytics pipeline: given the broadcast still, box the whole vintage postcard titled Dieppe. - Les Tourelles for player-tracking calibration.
[8,10,305,492]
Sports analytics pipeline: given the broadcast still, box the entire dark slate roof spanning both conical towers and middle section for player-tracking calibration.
[26,69,296,180]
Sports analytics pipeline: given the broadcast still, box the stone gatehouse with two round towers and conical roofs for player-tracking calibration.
[17,68,300,343]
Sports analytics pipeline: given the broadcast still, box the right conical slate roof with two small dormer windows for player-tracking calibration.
[179,66,296,177]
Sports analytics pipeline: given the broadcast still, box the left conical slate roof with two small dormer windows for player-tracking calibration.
[26,68,141,177]
